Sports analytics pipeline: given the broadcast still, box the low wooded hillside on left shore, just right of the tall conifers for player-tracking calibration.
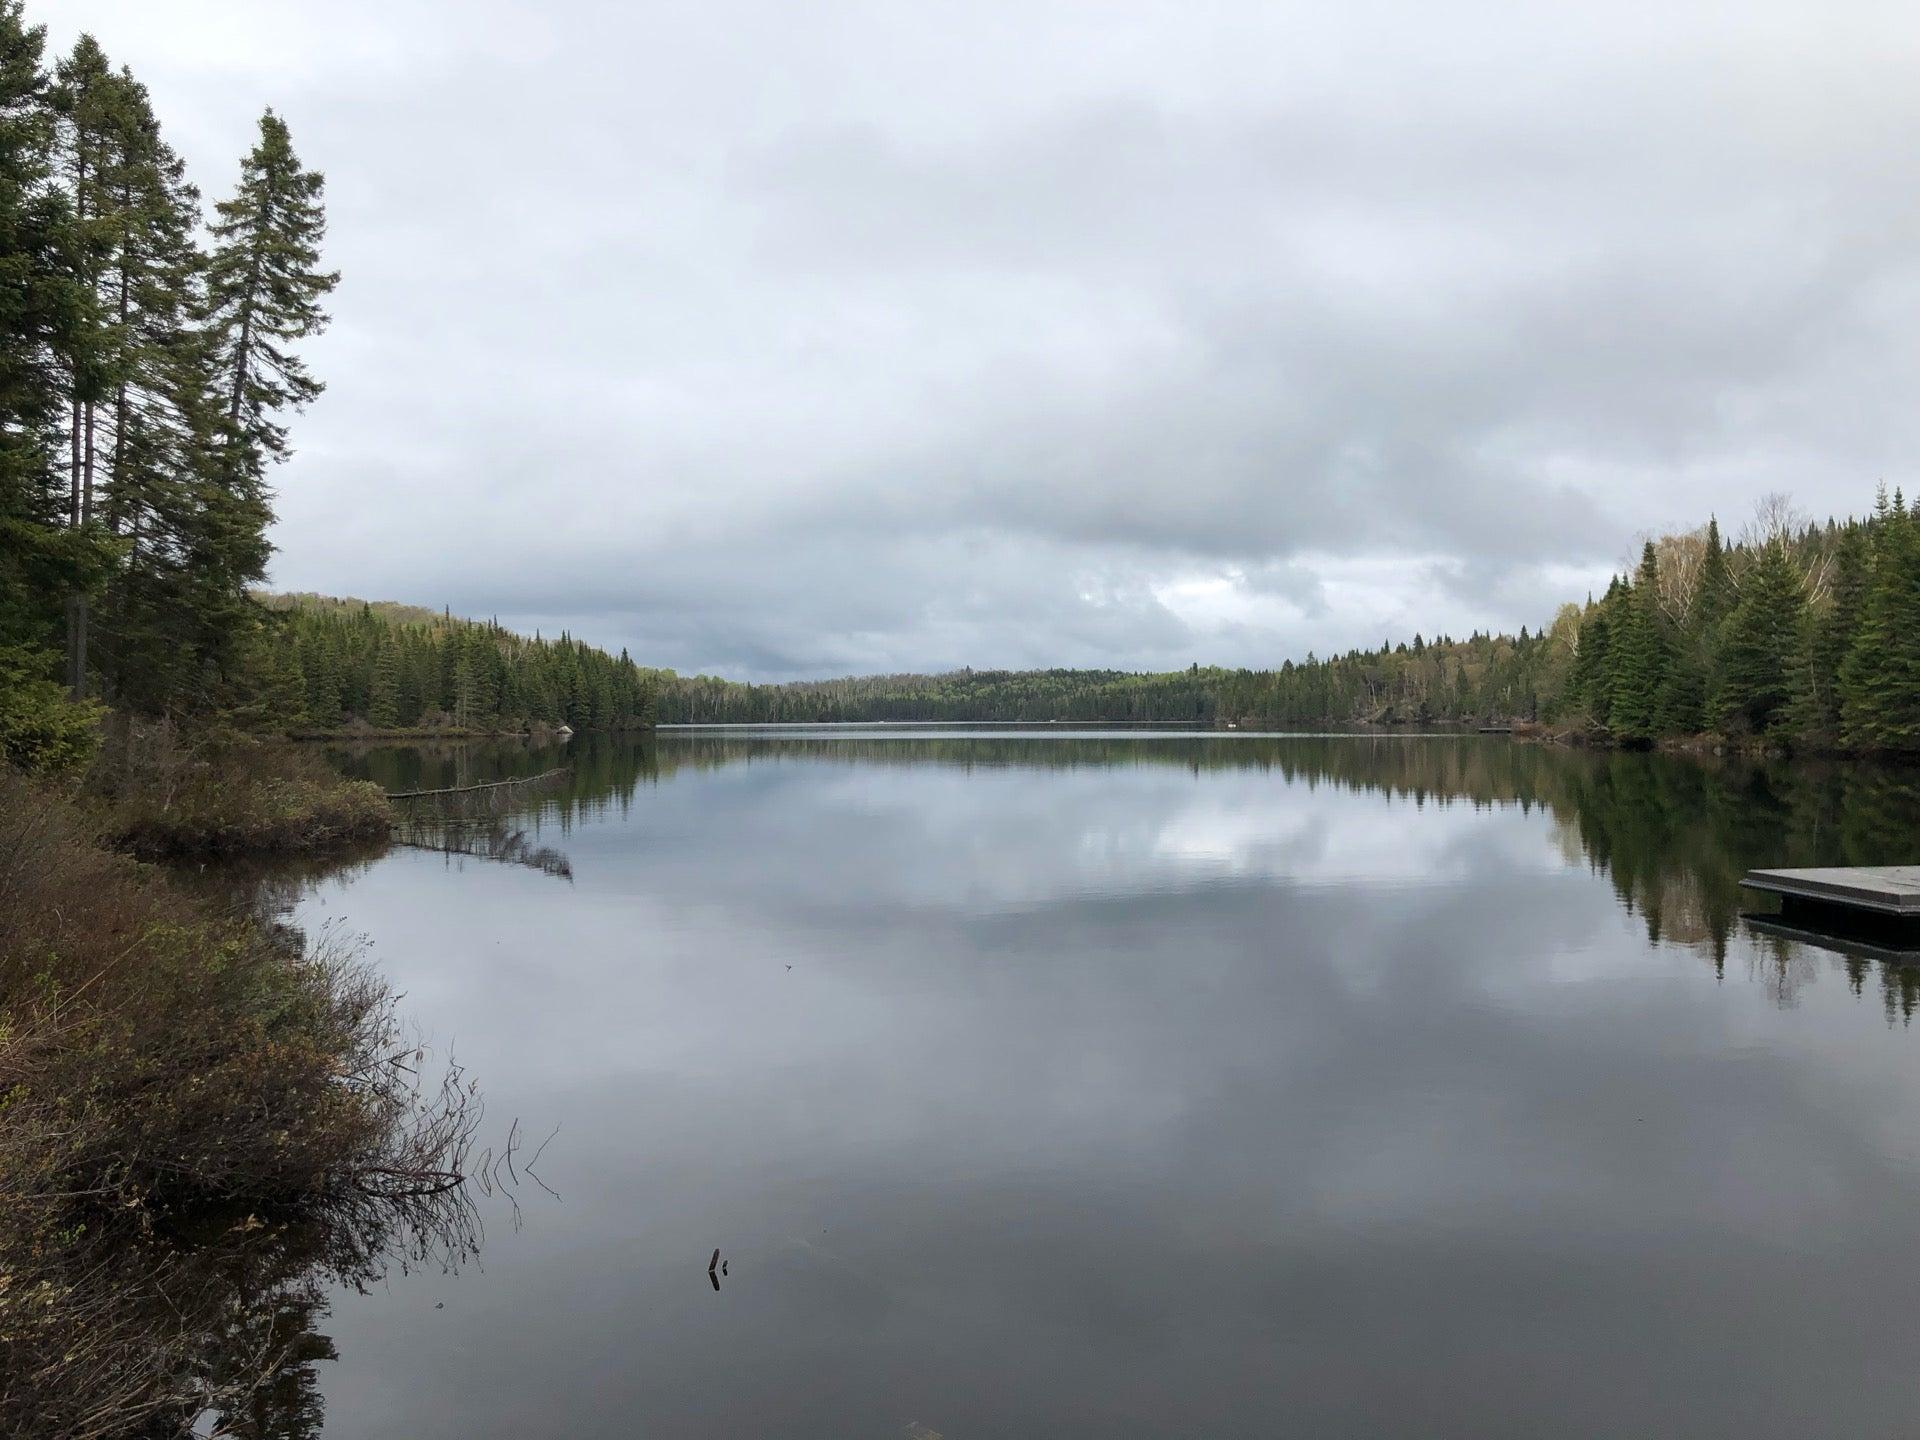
[261,595,657,732]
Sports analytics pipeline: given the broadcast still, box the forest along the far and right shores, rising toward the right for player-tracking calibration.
[660,493,1920,751]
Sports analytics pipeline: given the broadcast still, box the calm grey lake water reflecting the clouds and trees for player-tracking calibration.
[266,728,1920,1440]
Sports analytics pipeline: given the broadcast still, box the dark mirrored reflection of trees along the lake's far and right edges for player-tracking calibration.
[336,726,1920,1023]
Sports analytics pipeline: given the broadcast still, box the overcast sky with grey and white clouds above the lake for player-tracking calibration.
[29,0,1920,678]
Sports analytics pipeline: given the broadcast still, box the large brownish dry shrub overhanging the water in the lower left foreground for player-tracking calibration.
[0,772,480,1440]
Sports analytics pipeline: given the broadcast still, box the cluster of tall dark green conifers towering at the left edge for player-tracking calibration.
[0,11,334,714]
